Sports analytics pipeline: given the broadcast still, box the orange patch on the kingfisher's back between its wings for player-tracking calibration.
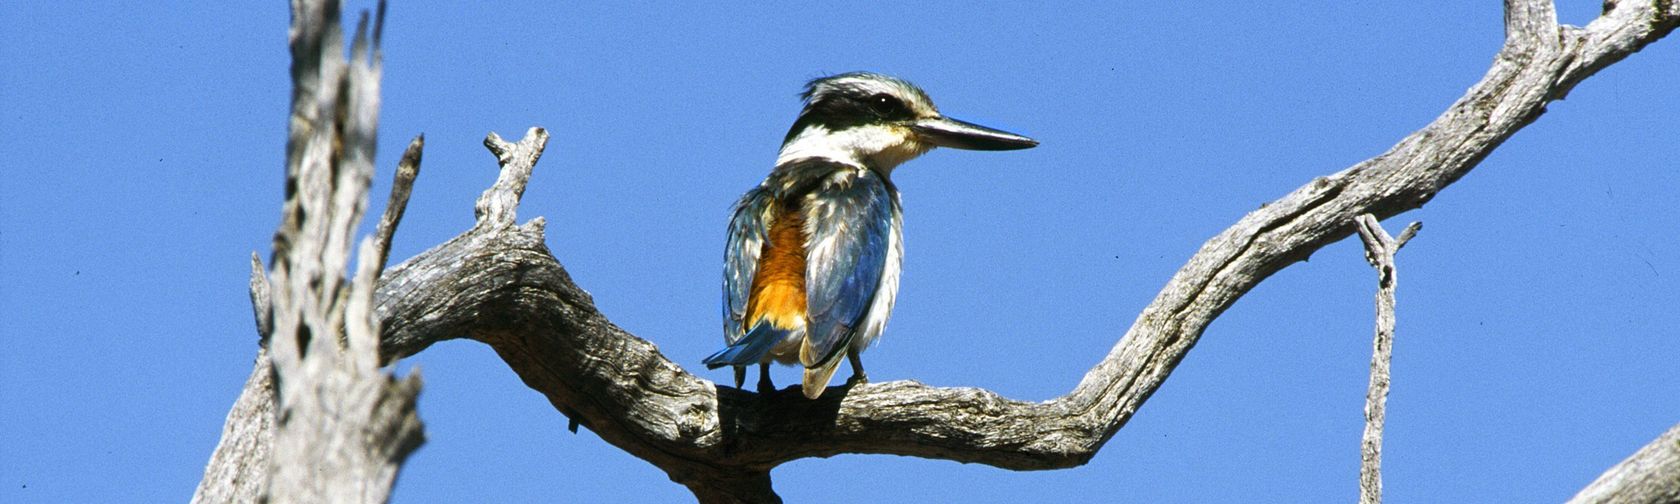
[746,205,805,329]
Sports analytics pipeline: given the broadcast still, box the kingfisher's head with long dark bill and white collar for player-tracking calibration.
[776,72,1038,173]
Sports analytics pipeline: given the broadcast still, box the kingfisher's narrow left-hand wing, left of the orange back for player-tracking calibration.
[724,186,774,344]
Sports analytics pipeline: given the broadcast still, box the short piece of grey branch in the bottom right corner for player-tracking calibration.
[1569,423,1680,504]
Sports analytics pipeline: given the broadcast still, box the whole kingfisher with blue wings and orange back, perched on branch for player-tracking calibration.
[706,72,1038,400]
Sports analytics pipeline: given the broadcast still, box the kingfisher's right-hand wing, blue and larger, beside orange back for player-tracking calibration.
[800,170,895,368]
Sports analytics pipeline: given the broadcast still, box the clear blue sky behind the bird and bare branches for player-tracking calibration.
[0,0,1680,502]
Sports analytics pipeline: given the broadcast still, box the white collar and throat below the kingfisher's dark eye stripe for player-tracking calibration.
[776,124,934,175]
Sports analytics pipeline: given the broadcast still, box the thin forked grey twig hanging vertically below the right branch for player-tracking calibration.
[1354,213,1423,504]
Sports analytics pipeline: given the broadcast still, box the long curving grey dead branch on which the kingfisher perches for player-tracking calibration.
[207,0,1680,502]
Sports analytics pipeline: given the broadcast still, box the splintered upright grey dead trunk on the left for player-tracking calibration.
[193,0,422,502]
